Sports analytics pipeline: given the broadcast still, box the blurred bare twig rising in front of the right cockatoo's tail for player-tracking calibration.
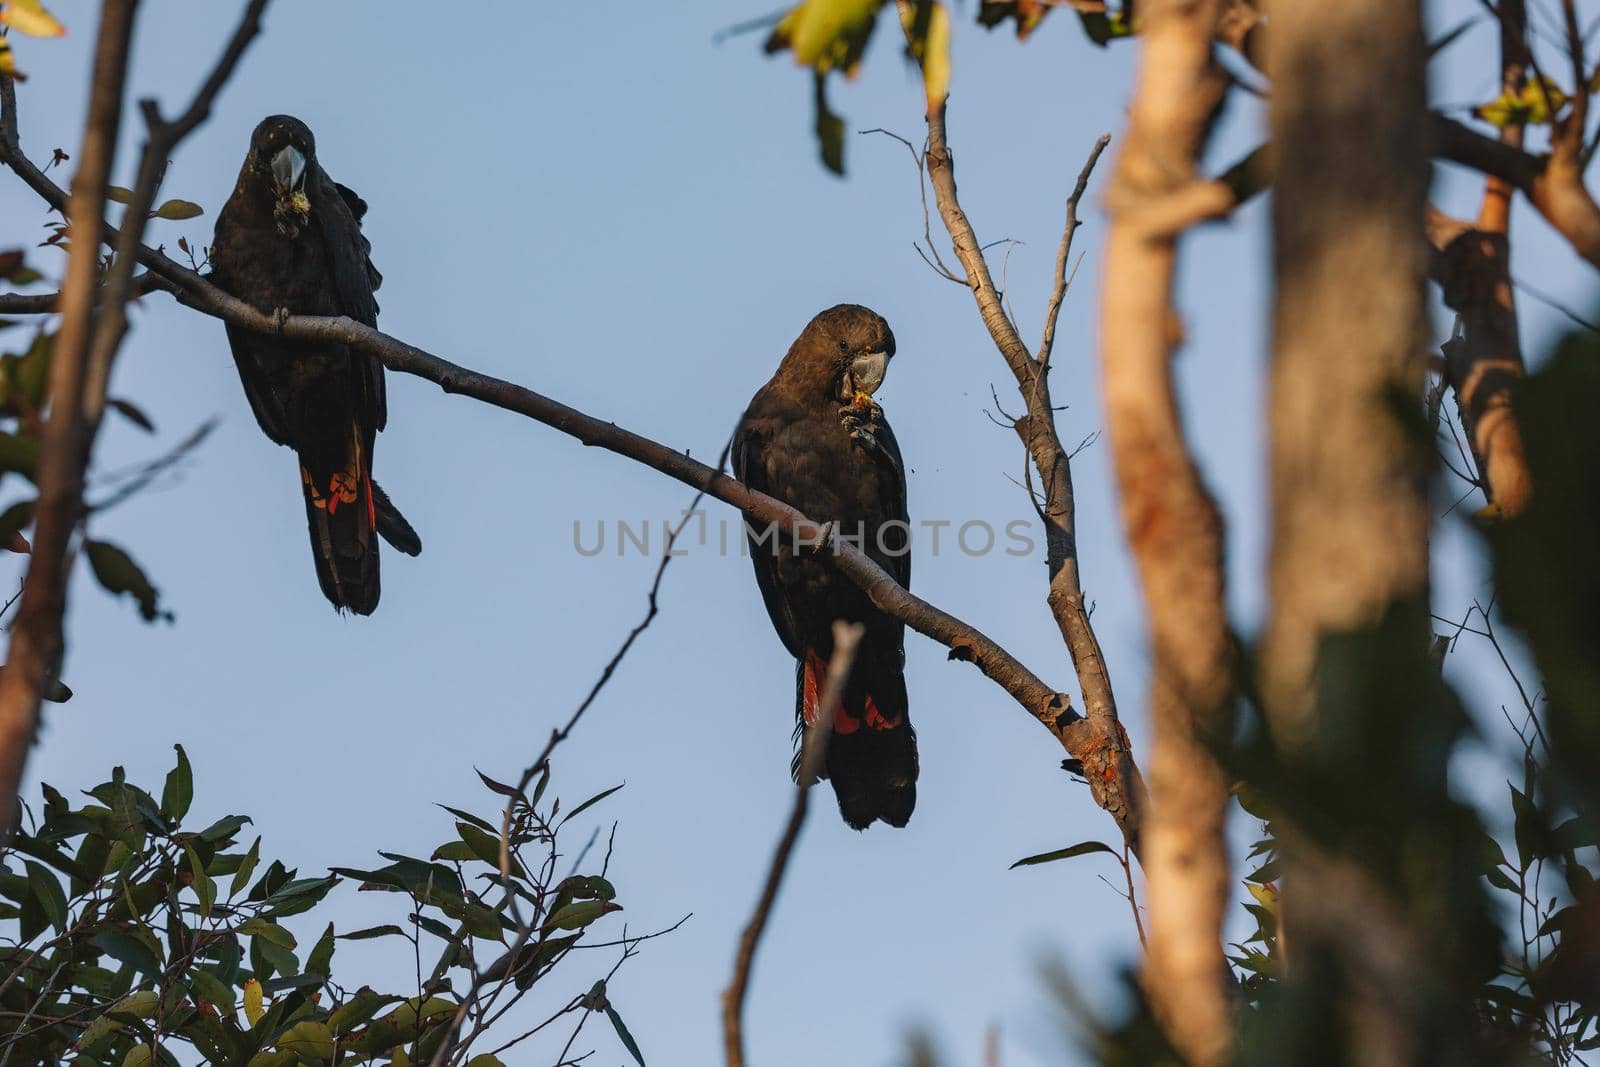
[722,619,866,1067]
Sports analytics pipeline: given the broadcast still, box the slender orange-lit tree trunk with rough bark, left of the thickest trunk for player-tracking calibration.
[1101,0,1234,1064]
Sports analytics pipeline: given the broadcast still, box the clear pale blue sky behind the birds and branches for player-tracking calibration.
[0,0,1590,1067]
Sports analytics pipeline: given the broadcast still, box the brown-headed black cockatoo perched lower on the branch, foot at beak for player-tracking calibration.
[731,304,917,830]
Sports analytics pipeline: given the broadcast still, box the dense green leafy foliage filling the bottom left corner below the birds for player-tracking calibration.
[0,747,662,1067]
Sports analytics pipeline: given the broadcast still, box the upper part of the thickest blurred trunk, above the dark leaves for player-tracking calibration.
[1262,0,1429,741]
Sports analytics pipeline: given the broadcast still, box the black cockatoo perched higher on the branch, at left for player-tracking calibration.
[211,115,422,614]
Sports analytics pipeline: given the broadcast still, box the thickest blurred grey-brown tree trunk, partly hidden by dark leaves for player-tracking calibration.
[1261,0,1443,1064]
